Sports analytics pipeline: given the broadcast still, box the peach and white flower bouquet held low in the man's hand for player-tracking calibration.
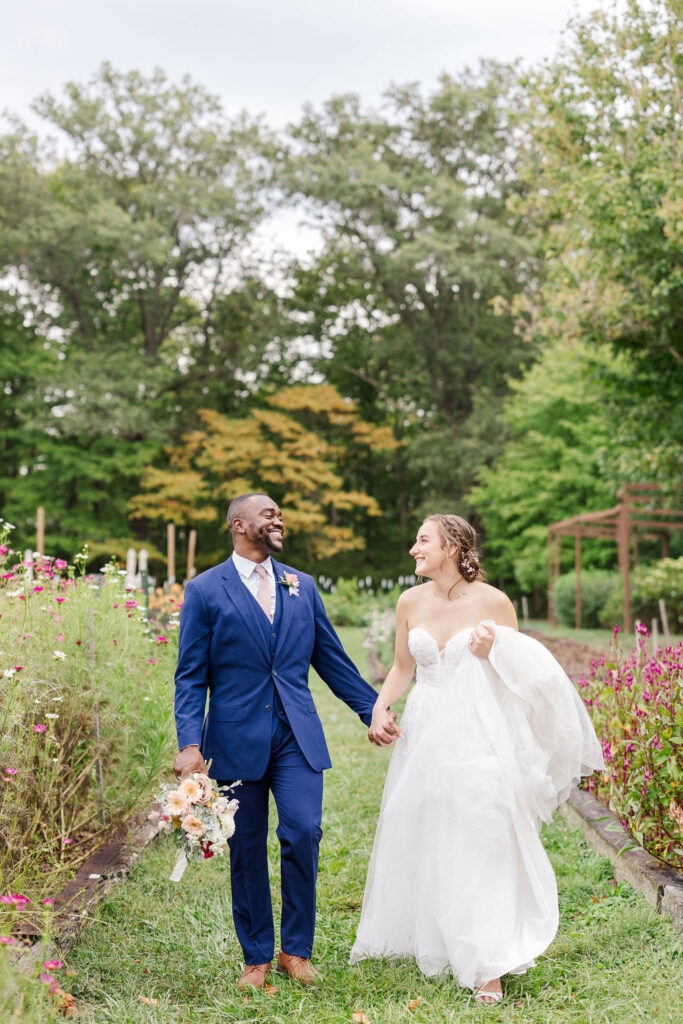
[150,772,241,882]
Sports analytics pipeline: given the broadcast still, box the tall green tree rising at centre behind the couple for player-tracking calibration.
[281,63,537,528]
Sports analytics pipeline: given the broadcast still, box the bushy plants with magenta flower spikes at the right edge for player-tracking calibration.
[579,626,683,868]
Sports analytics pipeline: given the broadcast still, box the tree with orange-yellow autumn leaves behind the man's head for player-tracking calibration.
[130,384,395,562]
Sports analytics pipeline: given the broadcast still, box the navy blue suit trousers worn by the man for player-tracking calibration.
[220,692,323,964]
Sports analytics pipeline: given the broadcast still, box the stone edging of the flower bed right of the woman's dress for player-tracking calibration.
[560,790,683,935]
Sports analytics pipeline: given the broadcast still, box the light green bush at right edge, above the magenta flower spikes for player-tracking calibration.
[601,558,683,633]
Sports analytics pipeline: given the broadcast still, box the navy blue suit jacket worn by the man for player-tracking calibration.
[175,558,377,780]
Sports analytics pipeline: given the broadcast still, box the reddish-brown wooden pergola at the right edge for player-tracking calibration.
[548,483,683,631]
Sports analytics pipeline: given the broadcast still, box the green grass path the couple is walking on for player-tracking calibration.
[61,630,683,1024]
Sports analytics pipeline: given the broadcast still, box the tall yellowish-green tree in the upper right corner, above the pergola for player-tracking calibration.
[522,0,683,485]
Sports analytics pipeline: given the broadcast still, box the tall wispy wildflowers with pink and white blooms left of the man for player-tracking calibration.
[0,524,176,916]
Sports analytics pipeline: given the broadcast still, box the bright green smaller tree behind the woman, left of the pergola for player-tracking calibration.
[468,340,630,593]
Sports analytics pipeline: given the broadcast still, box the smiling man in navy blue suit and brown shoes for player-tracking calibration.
[173,494,395,989]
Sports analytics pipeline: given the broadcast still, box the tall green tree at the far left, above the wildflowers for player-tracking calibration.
[0,65,267,553]
